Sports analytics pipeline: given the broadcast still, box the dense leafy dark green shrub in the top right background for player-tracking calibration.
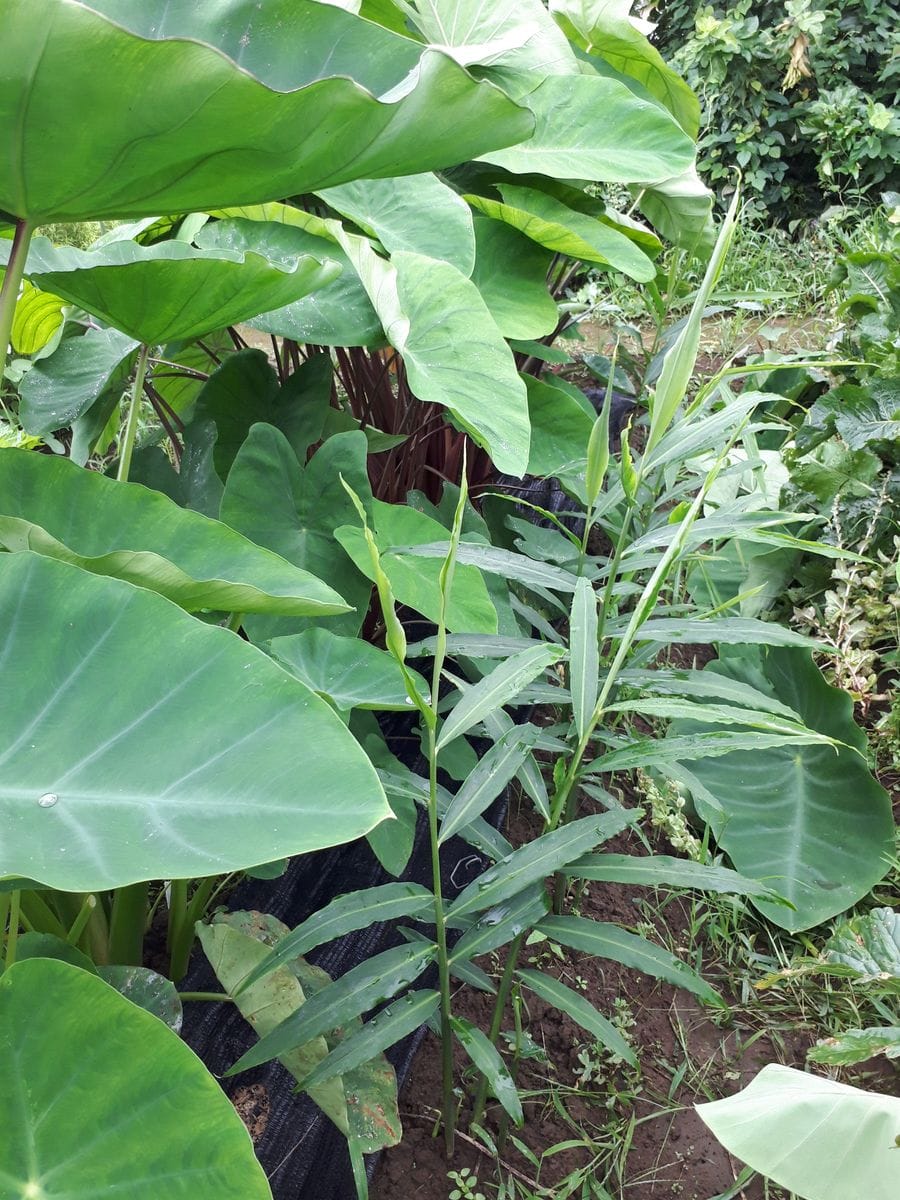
[656,0,900,222]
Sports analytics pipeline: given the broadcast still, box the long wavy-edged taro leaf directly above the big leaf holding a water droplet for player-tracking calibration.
[0,450,348,616]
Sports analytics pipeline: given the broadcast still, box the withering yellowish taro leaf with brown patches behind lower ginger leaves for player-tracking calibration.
[204,912,401,1154]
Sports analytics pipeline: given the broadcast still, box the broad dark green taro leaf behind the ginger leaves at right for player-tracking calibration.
[672,646,894,932]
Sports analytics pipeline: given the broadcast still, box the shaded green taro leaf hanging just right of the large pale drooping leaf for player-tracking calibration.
[472,214,559,338]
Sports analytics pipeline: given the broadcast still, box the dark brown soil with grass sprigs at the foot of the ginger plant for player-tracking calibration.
[372,796,815,1200]
